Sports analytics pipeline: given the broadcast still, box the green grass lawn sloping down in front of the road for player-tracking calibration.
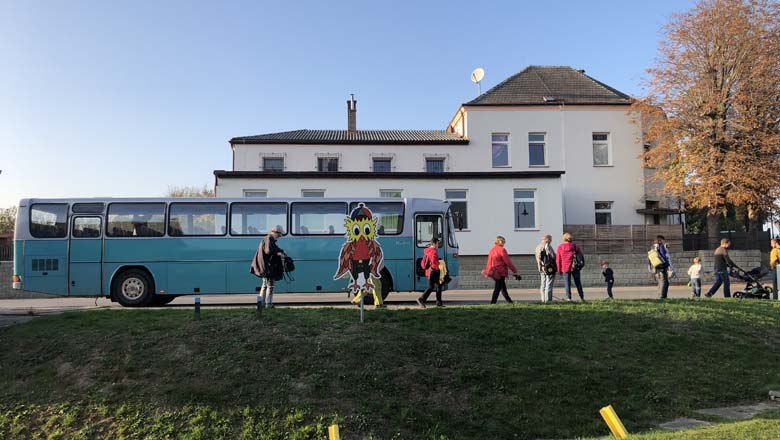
[0,300,780,439]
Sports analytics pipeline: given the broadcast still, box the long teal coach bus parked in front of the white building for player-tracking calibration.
[12,198,458,306]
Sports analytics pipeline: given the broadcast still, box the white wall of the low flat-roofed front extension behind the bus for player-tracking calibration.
[217,178,563,255]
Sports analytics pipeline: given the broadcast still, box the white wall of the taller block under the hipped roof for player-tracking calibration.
[467,106,644,225]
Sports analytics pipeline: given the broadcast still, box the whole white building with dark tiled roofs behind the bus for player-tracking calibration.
[214,66,667,255]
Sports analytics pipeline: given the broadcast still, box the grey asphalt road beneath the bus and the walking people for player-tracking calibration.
[0,286,722,316]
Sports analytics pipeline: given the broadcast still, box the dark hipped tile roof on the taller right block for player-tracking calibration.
[465,66,631,105]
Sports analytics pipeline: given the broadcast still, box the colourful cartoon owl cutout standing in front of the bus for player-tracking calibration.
[333,203,384,306]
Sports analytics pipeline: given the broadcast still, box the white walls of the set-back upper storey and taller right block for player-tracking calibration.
[234,106,645,230]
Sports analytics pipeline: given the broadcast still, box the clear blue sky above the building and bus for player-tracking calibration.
[0,0,693,207]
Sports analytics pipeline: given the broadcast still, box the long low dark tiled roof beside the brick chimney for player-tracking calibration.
[230,130,469,145]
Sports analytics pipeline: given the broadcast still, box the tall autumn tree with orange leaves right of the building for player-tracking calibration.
[635,0,780,242]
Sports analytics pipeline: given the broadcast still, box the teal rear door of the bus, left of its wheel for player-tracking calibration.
[68,216,103,295]
